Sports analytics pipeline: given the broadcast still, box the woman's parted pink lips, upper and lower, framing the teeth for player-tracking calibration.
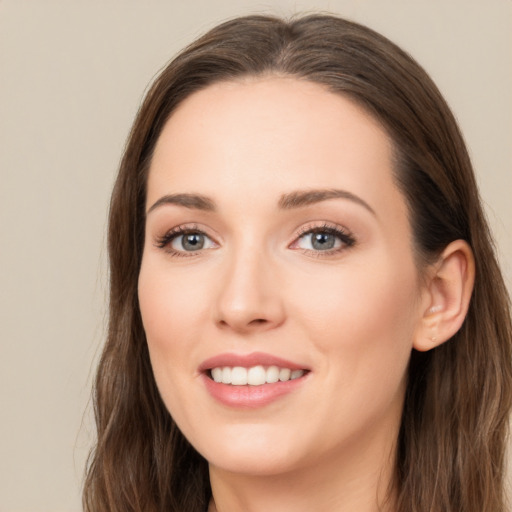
[199,352,310,409]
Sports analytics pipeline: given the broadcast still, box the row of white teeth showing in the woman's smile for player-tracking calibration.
[211,365,304,386]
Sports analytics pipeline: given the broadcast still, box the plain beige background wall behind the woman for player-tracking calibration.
[0,0,512,512]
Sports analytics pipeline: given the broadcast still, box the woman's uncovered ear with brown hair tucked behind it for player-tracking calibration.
[413,240,475,352]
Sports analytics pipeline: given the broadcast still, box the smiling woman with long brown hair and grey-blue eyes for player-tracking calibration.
[84,16,512,512]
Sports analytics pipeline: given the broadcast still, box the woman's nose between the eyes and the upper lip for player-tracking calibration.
[215,248,285,334]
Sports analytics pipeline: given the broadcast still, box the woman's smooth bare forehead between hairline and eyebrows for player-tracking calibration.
[147,77,402,223]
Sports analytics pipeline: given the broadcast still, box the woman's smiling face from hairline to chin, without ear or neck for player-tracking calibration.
[139,78,422,475]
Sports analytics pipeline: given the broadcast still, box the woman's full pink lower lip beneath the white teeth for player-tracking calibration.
[203,374,307,409]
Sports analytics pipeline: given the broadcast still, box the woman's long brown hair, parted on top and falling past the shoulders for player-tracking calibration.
[83,15,512,512]
